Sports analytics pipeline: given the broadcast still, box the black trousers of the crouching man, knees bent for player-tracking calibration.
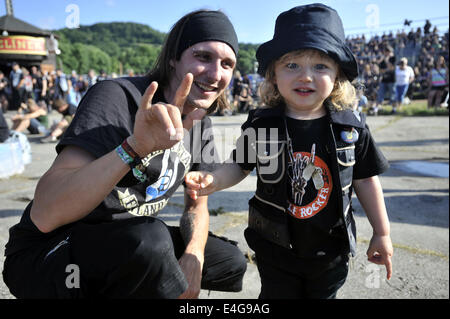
[3,217,247,298]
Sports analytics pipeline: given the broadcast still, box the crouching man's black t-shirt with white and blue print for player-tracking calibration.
[6,76,218,254]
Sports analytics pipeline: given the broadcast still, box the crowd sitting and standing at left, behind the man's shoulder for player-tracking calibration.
[0,62,120,143]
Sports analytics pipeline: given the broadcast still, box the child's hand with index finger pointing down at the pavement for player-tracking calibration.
[367,235,394,280]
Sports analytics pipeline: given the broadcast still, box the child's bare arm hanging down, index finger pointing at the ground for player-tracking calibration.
[353,176,393,279]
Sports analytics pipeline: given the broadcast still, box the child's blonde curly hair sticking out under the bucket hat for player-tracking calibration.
[261,49,357,111]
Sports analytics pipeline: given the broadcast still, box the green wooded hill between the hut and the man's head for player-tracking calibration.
[55,22,165,73]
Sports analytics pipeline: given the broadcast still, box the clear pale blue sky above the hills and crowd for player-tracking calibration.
[0,0,449,43]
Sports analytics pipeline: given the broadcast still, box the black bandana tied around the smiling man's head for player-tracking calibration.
[177,11,239,60]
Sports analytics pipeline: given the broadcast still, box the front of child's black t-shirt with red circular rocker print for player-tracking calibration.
[286,117,347,259]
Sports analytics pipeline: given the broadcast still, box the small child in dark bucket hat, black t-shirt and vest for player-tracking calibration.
[185,4,393,298]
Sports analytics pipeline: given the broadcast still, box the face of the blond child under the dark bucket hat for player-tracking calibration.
[274,50,339,116]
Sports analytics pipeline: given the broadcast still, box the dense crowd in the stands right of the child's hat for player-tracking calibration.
[347,20,449,114]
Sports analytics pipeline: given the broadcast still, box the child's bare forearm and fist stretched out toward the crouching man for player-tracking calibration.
[185,162,250,200]
